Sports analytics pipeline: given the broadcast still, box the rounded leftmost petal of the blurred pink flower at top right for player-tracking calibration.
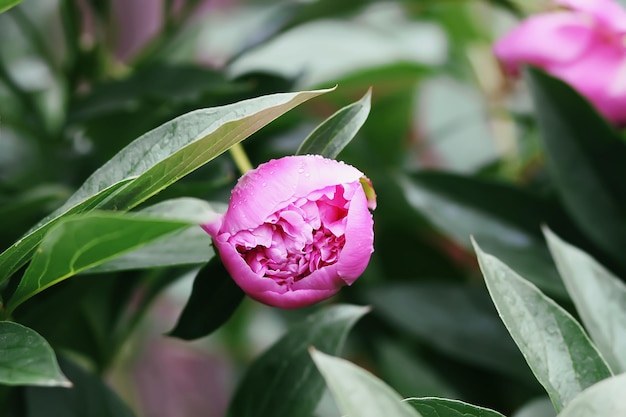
[494,11,593,73]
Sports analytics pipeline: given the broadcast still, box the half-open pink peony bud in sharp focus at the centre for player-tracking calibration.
[202,155,376,308]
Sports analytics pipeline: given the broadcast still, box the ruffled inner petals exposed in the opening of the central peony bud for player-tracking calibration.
[229,185,350,286]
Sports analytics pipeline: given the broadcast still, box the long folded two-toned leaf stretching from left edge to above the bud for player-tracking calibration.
[0,90,330,282]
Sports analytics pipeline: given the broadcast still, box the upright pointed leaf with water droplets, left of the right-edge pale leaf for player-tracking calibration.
[474,239,611,411]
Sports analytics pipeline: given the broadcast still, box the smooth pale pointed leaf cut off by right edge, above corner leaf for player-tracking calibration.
[544,228,626,374]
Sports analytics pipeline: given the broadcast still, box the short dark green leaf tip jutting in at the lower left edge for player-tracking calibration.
[0,321,72,387]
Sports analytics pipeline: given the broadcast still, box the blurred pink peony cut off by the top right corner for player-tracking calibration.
[494,0,626,125]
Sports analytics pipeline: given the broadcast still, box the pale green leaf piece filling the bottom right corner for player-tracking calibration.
[558,374,626,417]
